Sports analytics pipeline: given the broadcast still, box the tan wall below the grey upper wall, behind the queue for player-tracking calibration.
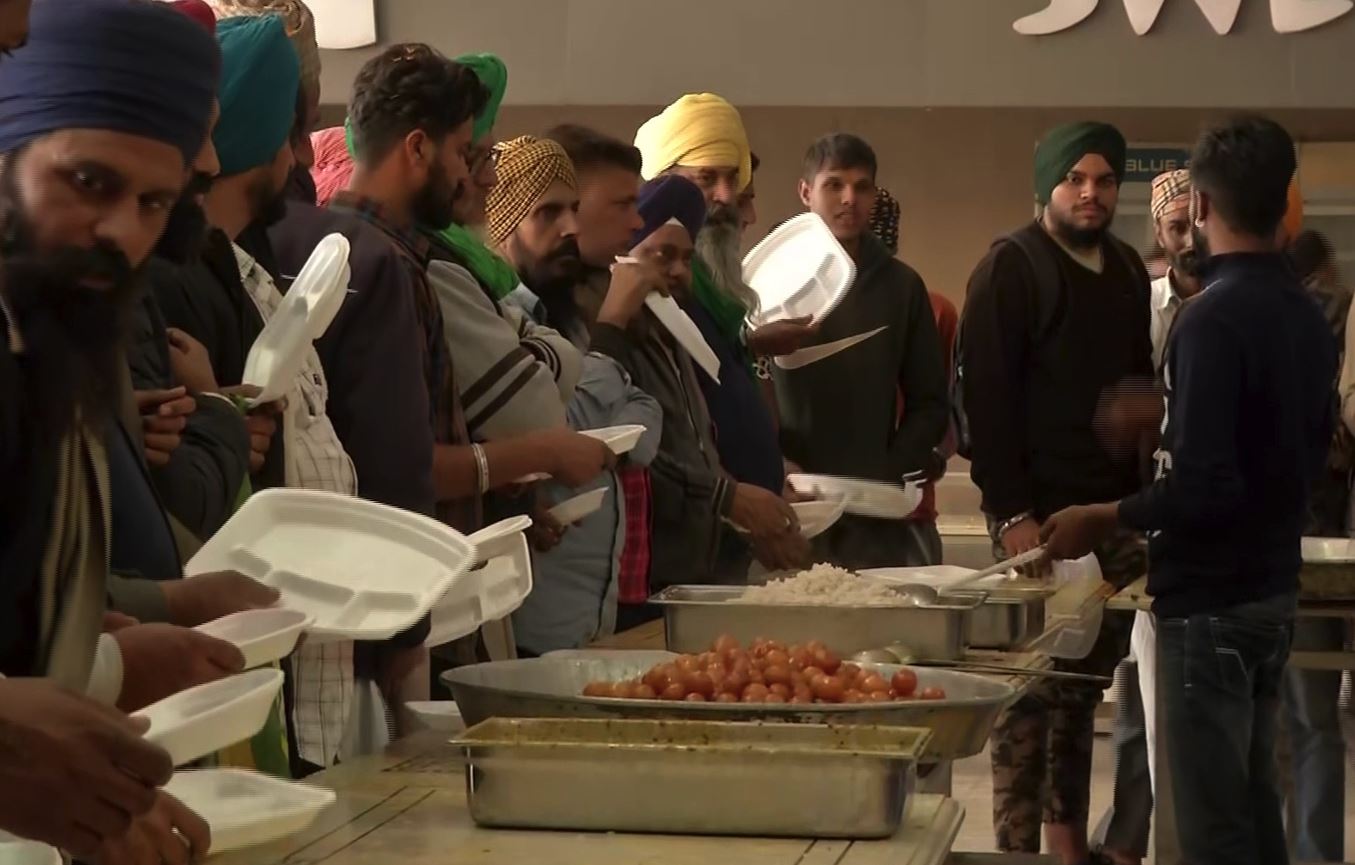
[449,106,1355,313]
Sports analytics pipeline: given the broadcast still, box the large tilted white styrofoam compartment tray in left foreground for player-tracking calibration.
[187,489,476,641]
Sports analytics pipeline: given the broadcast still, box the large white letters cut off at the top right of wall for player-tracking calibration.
[1012,0,1355,37]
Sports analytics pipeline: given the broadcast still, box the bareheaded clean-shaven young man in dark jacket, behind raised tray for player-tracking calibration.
[772,134,950,569]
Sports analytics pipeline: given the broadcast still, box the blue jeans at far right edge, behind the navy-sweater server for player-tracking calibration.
[1285,618,1346,862]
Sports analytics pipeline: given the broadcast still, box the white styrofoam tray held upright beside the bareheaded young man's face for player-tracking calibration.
[744,213,856,327]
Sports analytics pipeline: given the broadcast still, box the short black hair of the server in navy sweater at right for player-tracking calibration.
[1190,114,1298,237]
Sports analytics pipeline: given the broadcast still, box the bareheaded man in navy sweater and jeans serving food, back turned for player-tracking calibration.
[1042,117,1336,865]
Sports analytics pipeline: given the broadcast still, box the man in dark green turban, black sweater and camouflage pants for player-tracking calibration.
[957,122,1153,862]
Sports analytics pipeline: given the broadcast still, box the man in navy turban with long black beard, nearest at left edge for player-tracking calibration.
[0,0,243,862]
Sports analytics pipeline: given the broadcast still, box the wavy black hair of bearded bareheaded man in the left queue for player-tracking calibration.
[348,43,489,160]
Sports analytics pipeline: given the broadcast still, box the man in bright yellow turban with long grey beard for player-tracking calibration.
[635,94,812,579]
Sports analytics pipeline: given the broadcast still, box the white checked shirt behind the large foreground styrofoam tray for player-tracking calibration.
[232,244,358,767]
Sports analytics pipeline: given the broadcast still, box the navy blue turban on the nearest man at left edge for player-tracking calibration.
[0,0,221,164]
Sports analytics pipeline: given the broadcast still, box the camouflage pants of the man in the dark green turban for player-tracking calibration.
[991,520,1148,853]
